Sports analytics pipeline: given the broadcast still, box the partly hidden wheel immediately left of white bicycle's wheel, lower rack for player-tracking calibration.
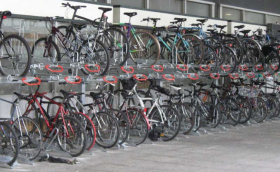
[126,108,149,145]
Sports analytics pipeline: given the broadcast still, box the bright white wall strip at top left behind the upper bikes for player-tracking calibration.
[0,0,113,22]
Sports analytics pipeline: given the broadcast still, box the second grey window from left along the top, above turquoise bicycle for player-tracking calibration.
[150,0,183,13]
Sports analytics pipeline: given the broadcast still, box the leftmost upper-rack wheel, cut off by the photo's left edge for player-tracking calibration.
[0,35,31,76]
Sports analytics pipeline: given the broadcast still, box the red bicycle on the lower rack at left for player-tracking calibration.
[16,85,91,157]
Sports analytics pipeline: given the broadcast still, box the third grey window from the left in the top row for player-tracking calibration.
[187,1,212,17]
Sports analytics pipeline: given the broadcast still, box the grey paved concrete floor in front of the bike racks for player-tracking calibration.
[3,120,280,172]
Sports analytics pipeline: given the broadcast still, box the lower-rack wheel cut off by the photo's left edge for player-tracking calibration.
[0,122,19,166]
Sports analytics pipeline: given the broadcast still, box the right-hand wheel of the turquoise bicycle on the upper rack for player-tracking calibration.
[176,35,204,65]
